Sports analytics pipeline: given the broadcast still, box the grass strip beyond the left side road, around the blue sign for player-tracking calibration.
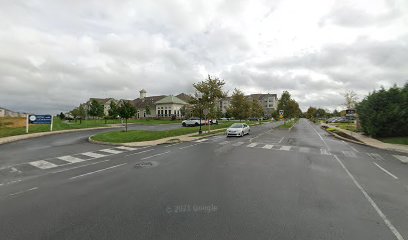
[0,117,181,137]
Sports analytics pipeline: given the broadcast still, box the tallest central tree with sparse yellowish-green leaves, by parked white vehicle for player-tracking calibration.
[190,75,226,118]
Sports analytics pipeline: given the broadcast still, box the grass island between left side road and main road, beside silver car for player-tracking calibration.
[92,123,230,143]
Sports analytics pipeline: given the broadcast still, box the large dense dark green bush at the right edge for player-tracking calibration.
[357,83,408,137]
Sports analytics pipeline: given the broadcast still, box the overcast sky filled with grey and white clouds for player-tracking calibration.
[0,0,408,113]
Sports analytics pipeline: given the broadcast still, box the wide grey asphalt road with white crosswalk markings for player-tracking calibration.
[0,119,408,240]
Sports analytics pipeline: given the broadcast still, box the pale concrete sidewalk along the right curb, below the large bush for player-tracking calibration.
[320,123,408,153]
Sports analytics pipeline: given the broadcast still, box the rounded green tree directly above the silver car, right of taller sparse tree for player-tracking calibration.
[229,89,251,121]
